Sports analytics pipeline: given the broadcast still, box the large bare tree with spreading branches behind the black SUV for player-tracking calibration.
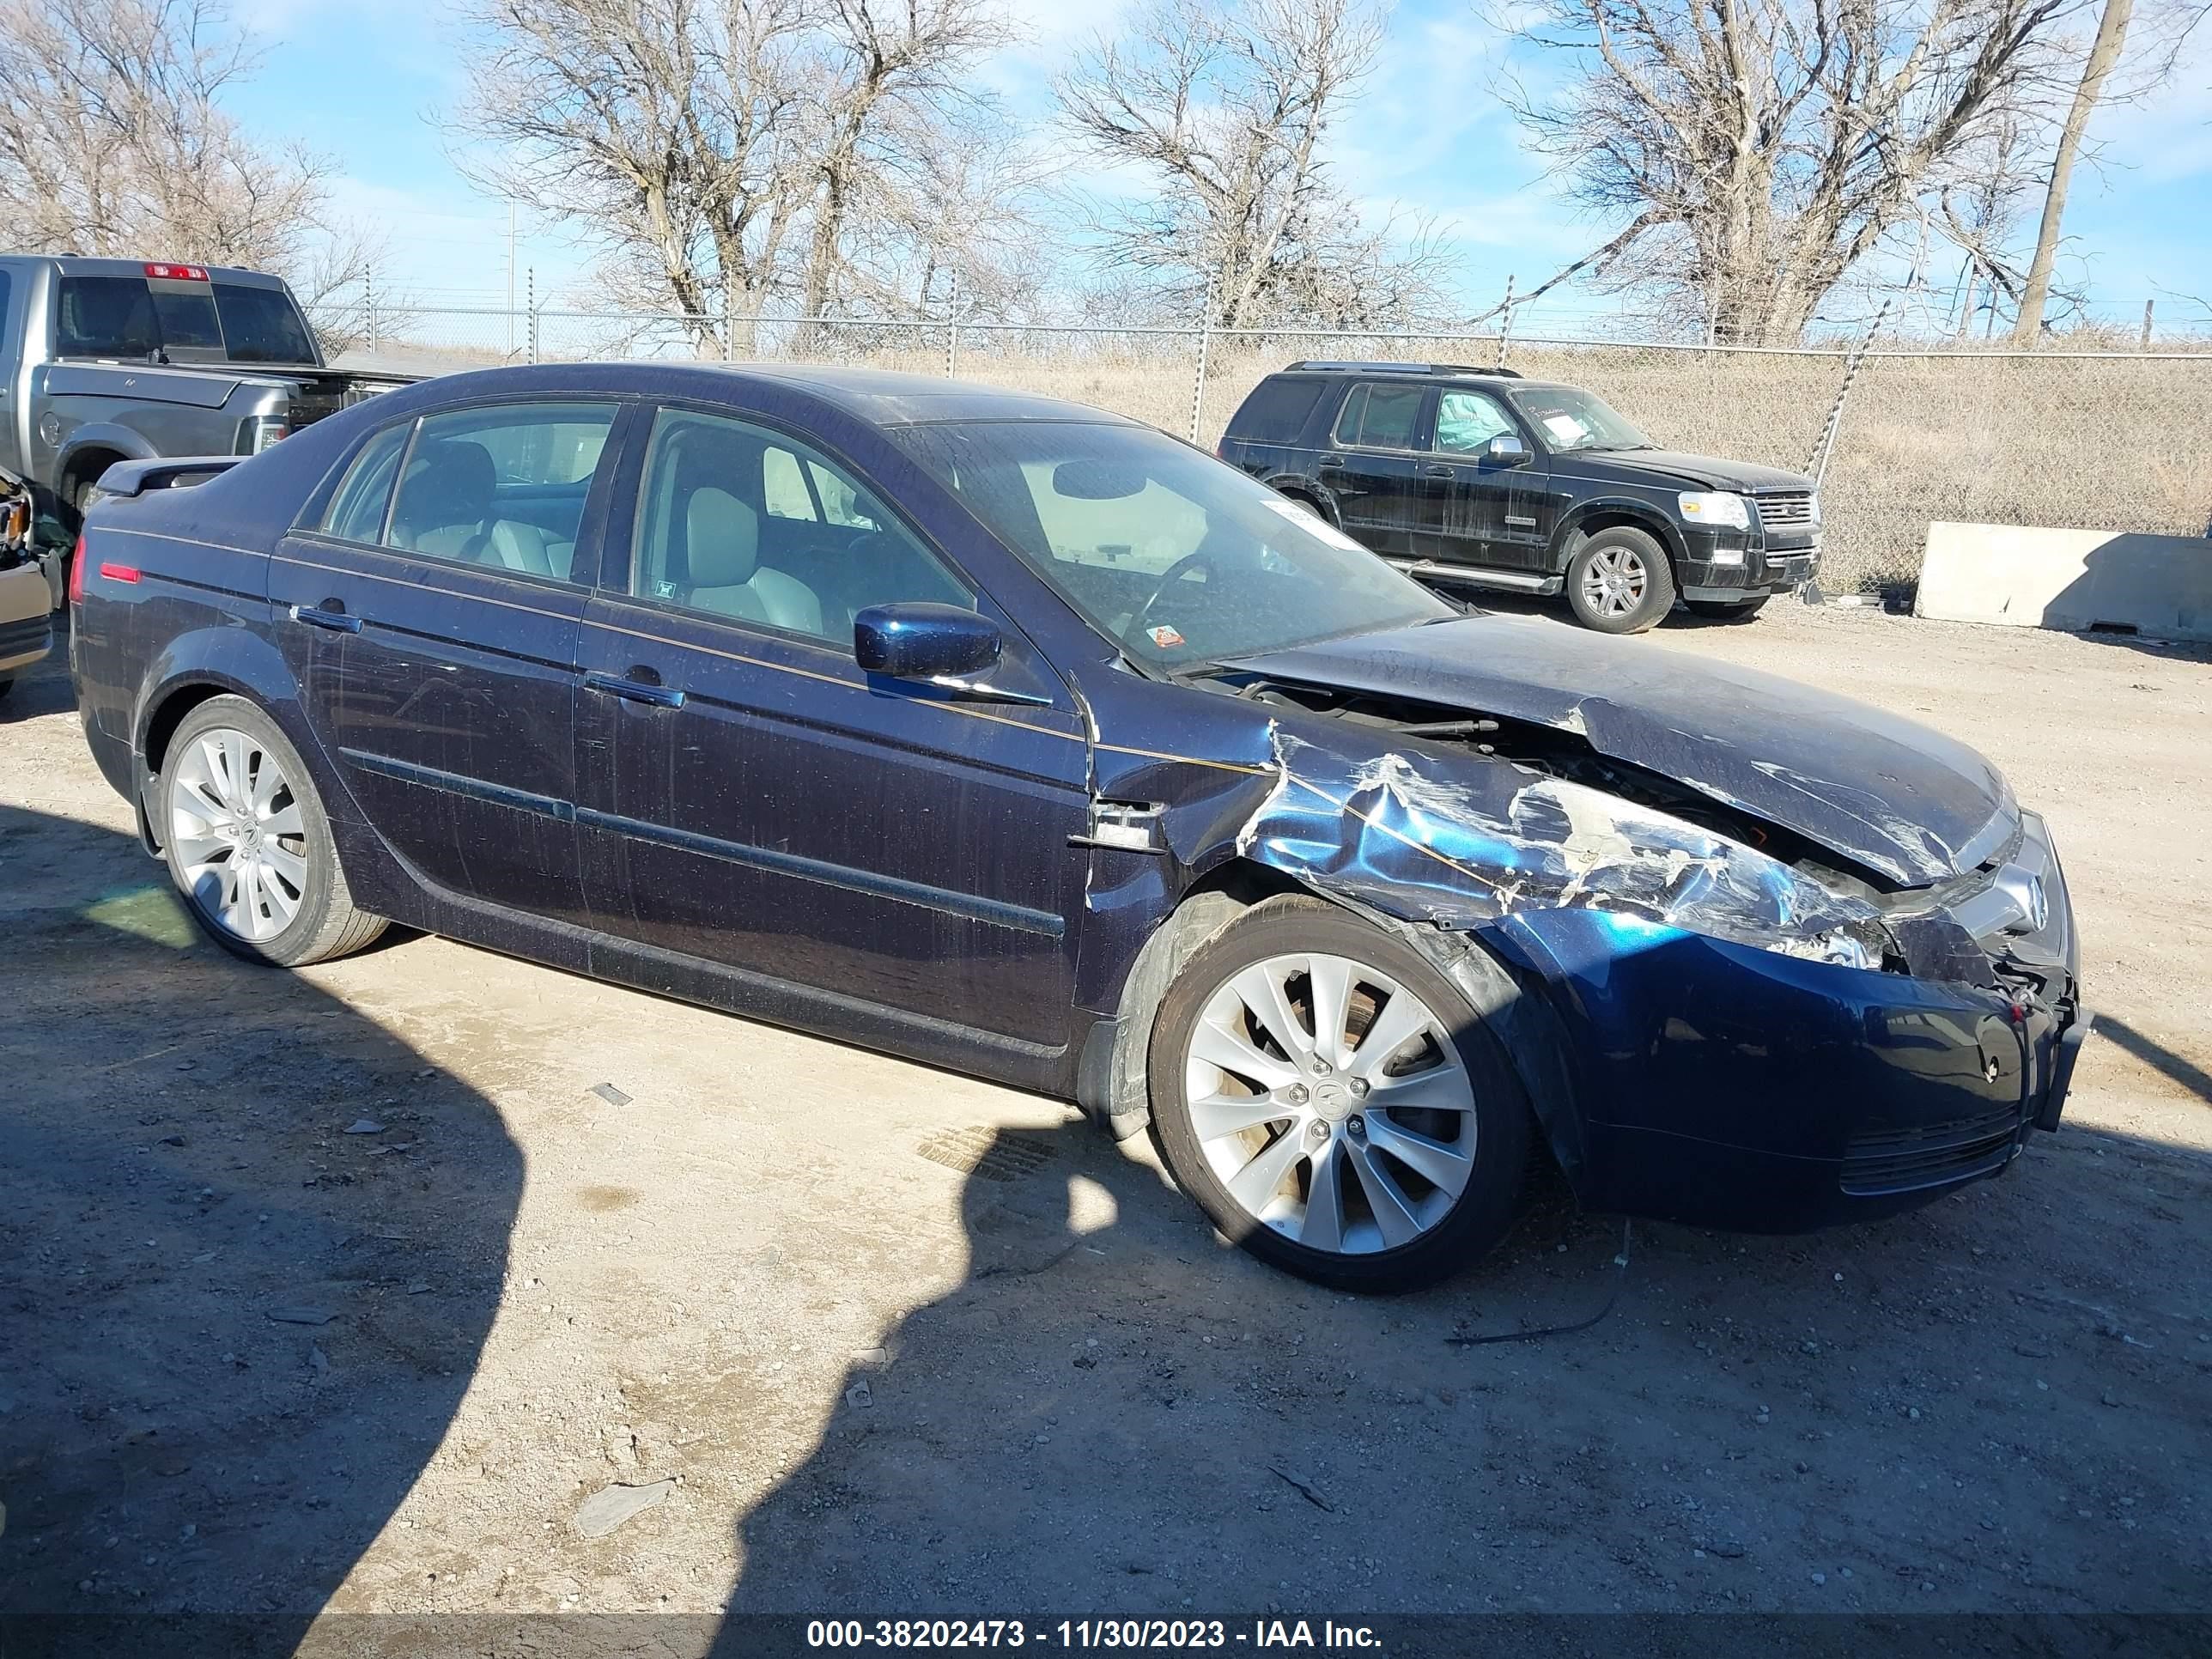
[1506,0,2079,343]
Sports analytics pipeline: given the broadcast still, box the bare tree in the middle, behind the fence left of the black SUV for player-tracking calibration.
[1057,0,1440,327]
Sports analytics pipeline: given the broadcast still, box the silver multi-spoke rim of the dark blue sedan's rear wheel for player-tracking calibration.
[168,726,307,945]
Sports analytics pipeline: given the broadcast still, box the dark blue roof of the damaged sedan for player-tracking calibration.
[386,358,1144,427]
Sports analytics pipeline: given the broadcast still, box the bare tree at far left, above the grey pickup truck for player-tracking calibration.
[0,0,330,272]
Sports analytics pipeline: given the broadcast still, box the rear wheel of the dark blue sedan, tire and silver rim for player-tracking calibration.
[159,696,385,967]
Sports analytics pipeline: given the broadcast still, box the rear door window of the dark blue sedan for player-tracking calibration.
[382,403,615,581]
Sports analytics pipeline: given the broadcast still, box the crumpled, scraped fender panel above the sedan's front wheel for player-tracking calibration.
[1237,726,1881,963]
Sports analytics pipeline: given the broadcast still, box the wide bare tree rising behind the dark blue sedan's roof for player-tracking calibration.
[456,0,1035,347]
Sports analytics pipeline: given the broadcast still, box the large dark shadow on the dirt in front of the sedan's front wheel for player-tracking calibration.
[714,1084,2212,1627]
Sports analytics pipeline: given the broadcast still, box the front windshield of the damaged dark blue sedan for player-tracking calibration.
[890,420,1458,668]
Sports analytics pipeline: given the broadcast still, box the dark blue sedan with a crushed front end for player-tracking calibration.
[70,365,2088,1287]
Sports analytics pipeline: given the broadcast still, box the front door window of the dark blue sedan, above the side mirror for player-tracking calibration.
[630,410,975,648]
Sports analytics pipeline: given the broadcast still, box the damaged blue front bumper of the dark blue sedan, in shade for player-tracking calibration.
[1489,814,2090,1232]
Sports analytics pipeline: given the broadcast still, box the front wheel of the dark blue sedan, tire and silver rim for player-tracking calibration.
[1151,898,1531,1291]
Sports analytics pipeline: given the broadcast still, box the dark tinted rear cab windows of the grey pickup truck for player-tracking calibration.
[55,276,314,362]
